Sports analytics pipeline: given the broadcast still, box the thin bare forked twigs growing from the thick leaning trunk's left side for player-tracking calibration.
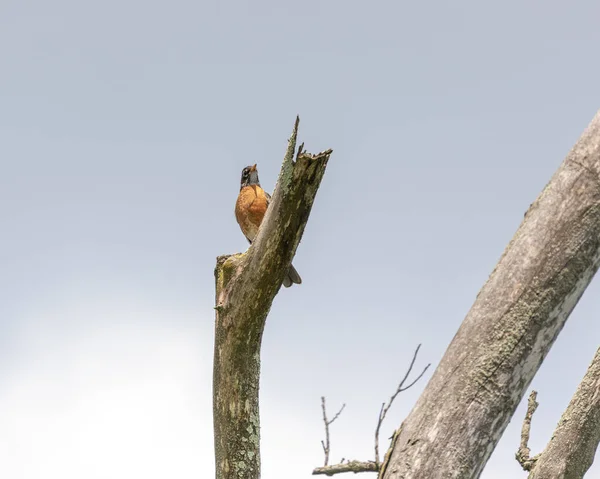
[313,344,431,476]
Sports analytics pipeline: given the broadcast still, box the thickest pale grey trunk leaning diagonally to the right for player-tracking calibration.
[383,109,600,479]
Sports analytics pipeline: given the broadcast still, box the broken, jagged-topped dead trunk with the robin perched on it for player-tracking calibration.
[213,119,331,479]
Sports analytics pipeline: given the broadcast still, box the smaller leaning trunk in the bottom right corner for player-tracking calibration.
[529,349,600,479]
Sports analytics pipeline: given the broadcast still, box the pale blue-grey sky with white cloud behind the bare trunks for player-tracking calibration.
[0,0,600,479]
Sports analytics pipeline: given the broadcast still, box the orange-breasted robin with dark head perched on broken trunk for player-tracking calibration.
[235,165,302,288]
